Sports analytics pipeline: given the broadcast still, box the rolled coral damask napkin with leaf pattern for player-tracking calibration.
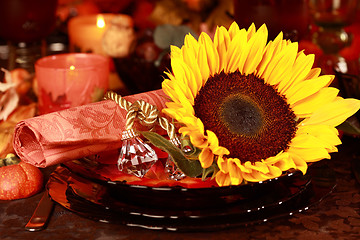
[14,90,167,167]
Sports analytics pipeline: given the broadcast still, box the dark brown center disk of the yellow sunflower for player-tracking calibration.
[194,72,296,162]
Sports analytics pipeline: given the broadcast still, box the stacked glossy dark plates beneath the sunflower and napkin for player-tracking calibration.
[47,162,336,231]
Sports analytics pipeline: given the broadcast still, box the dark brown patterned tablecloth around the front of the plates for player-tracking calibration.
[0,137,360,240]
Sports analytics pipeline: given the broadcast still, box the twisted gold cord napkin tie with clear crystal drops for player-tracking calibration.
[104,91,185,180]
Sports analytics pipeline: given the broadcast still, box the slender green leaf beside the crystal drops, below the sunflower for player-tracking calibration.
[140,132,203,177]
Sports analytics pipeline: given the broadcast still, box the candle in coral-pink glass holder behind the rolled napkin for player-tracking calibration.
[35,53,109,114]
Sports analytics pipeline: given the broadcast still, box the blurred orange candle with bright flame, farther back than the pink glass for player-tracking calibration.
[68,14,115,55]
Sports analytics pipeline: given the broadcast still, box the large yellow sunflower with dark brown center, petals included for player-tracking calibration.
[162,23,360,186]
